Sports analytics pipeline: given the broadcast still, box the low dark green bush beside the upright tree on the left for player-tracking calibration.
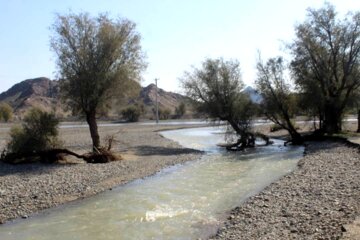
[7,108,59,153]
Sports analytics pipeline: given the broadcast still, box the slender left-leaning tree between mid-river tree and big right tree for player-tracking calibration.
[256,57,303,144]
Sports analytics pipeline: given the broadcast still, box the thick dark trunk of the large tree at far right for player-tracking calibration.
[323,103,342,133]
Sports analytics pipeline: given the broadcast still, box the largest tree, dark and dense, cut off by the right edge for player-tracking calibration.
[290,3,360,133]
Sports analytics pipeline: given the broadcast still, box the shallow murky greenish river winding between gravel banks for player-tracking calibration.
[0,127,303,240]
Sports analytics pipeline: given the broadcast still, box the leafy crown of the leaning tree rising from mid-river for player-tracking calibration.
[182,59,244,120]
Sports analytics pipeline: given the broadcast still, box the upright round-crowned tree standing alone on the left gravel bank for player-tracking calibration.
[51,13,145,150]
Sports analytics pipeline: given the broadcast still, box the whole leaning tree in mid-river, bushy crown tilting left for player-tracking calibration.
[182,58,262,149]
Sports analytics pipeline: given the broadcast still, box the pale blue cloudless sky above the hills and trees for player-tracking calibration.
[0,0,360,93]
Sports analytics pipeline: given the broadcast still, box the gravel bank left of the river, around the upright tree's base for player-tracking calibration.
[0,124,201,223]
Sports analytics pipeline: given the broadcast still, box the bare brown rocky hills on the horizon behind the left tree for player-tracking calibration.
[0,77,188,117]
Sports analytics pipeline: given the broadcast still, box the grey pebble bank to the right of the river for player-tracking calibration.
[214,142,360,239]
